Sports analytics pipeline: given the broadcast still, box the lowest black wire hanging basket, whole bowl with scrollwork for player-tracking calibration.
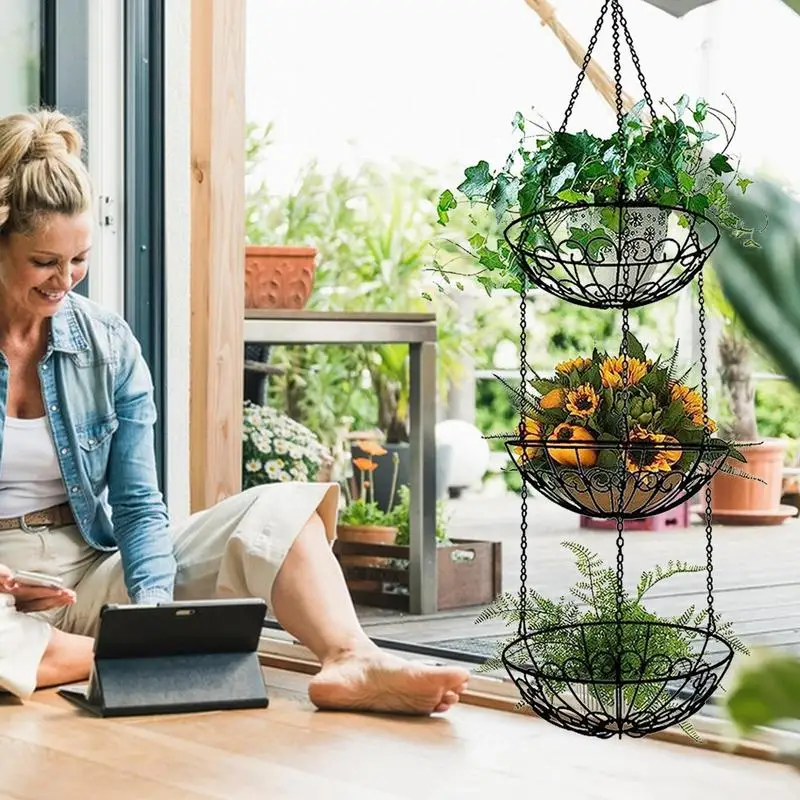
[502,621,733,739]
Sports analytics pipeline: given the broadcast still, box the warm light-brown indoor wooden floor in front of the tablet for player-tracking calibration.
[0,669,800,800]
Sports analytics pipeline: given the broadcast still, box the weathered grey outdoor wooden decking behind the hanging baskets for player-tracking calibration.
[359,478,800,652]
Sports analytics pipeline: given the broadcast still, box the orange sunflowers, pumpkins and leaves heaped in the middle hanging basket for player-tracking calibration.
[514,334,746,473]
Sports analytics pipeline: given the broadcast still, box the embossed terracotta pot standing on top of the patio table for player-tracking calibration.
[244,245,317,310]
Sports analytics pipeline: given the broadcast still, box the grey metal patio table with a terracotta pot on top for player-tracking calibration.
[244,309,437,614]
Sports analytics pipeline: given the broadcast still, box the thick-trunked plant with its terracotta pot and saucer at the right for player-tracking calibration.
[706,271,797,525]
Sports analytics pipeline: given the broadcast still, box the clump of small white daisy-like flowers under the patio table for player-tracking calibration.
[242,401,329,489]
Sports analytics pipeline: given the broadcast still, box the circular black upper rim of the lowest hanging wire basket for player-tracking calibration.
[500,620,733,686]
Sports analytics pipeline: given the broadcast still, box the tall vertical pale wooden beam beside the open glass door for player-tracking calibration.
[190,0,246,512]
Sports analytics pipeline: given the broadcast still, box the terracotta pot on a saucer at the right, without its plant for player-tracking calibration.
[712,439,796,525]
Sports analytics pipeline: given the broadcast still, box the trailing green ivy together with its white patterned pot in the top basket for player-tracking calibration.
[434,95,755,292]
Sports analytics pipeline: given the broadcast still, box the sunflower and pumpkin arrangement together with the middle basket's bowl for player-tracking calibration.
[507,334,745,518]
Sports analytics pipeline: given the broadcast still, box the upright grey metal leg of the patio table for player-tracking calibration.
[408,342,437,614]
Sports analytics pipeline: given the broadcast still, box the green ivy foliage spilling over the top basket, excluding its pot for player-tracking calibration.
[433,95,756,293]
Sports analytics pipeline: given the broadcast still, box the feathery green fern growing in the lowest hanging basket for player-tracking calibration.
[475,541,748,739]
